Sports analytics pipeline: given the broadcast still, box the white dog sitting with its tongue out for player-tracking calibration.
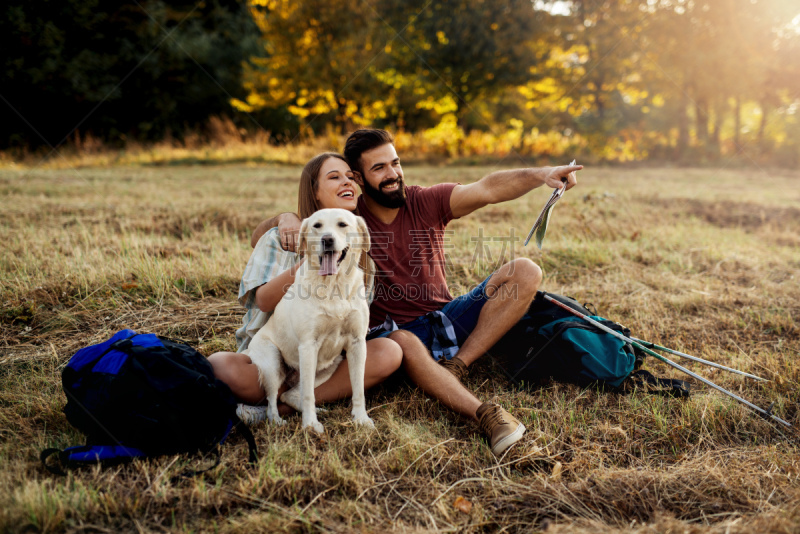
[248,209,374,433]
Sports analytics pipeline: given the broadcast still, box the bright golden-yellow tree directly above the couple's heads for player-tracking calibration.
[234,0,384,130]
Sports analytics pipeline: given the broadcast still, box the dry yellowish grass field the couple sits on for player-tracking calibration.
[0,161,800,533]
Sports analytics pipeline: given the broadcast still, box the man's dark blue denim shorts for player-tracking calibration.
[375,276,491,356]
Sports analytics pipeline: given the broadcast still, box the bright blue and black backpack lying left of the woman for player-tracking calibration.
[41,329,257,473]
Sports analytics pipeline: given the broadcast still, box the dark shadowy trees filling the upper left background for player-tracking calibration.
[0,0,258,149]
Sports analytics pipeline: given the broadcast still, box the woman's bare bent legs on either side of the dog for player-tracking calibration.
[208,338,403,406]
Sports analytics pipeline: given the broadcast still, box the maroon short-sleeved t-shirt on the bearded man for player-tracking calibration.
[358,184,458,327]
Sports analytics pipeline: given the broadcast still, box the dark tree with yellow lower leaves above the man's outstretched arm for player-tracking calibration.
[377,0,549,127]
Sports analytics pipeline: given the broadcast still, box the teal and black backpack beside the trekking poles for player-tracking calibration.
[489,291,689,397]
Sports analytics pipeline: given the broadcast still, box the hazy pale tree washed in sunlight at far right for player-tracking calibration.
[640,0,791,159]
